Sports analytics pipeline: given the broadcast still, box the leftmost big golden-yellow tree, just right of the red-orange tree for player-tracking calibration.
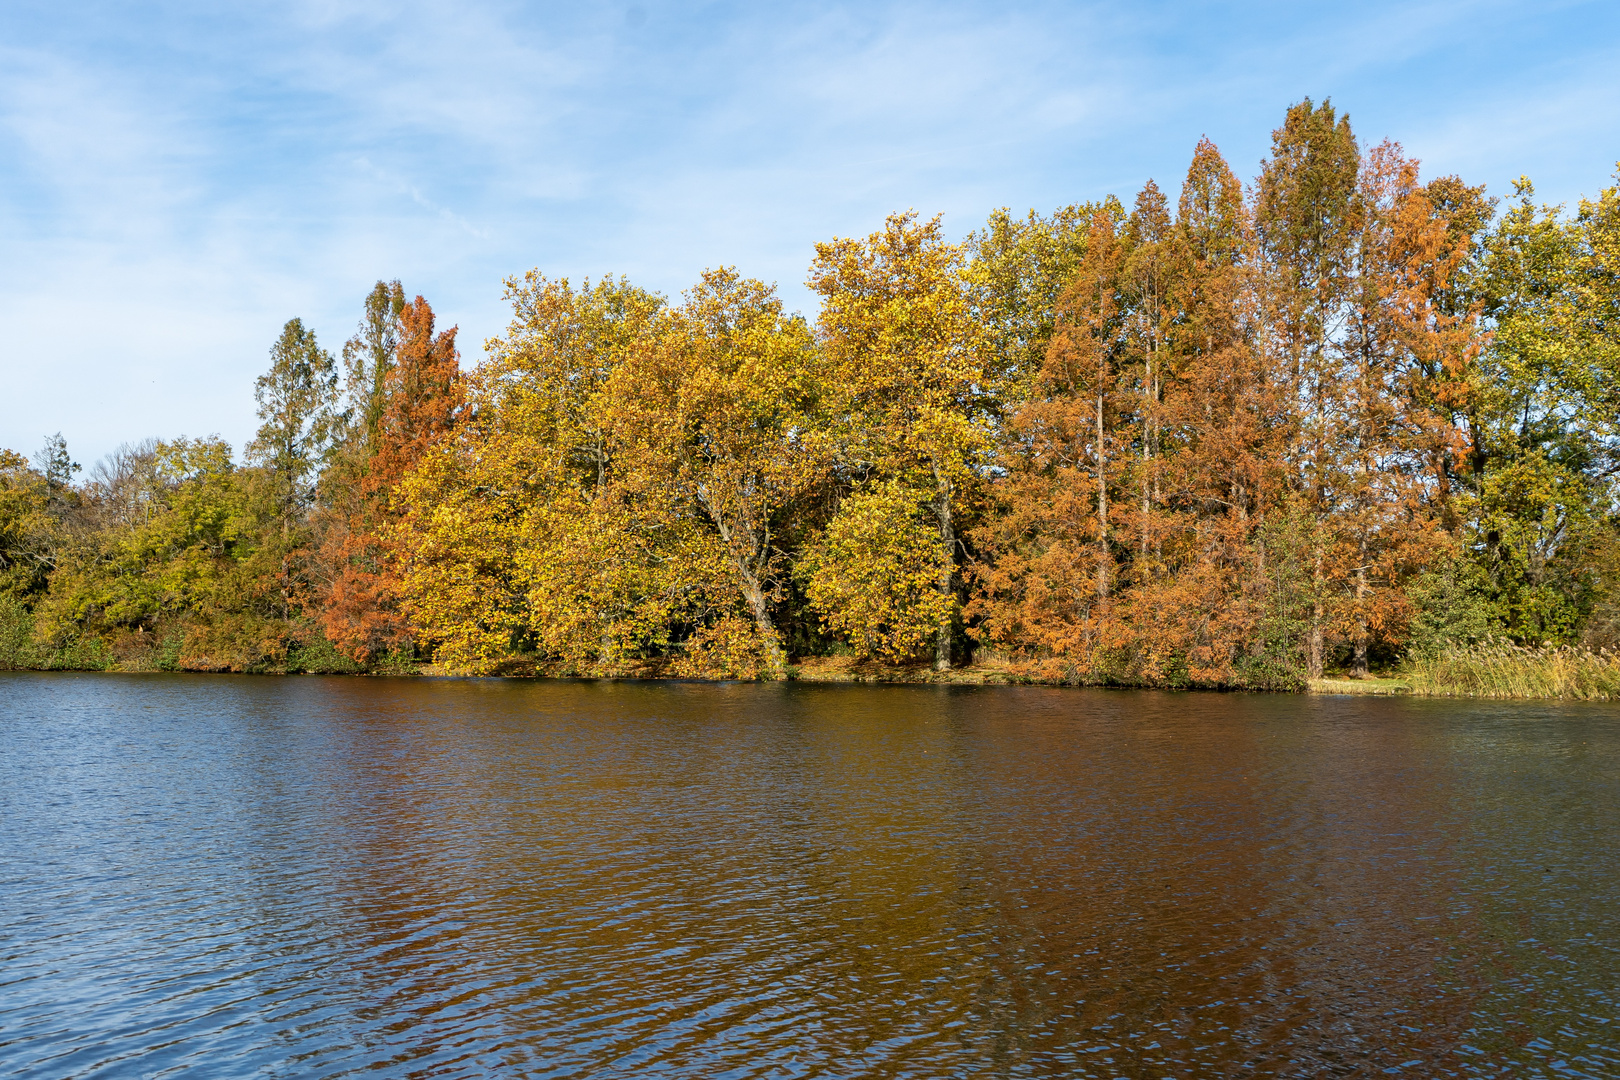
[395,272,670,672]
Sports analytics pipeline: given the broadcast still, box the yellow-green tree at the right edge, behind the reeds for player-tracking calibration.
[1466,169,1620,644]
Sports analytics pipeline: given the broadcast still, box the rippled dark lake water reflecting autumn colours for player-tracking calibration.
[0,675,1620,1078]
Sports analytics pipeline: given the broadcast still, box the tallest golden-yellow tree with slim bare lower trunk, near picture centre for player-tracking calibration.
[810,214,990,670]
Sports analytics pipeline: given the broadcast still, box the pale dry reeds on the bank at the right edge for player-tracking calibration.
[1406,640,1620,701]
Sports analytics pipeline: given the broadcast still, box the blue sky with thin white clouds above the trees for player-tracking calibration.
[0,0,1620,466]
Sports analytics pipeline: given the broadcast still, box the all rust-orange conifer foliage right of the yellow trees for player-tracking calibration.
[970,133,1477,685]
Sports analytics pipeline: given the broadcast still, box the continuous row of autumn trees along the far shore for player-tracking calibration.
[0,99,1620,688]
